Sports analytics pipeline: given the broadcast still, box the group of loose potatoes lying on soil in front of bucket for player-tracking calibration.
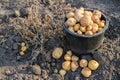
[52,47,99,77]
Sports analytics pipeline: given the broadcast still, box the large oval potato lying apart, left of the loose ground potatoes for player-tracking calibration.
[52,47,63,59]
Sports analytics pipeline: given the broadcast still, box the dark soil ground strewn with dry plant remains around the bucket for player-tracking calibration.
[0,0,120,80]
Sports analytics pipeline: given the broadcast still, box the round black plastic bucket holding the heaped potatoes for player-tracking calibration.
[63,10,109,55]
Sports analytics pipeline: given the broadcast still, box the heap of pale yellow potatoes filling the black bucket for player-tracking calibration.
[65,7,105,35]
